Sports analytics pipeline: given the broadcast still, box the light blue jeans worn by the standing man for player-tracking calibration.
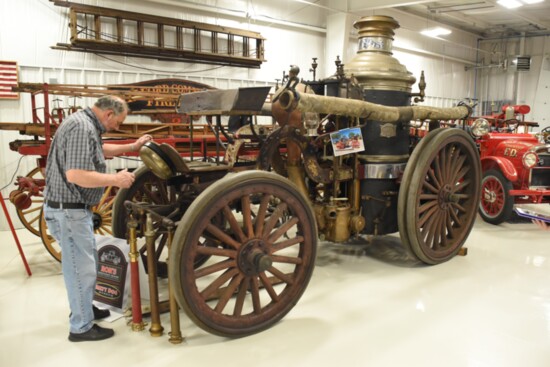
[44,203,98,333]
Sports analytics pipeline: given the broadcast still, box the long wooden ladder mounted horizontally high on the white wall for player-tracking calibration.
[52,0,265,68]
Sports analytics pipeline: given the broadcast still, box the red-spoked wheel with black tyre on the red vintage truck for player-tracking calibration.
[479,169,514,225]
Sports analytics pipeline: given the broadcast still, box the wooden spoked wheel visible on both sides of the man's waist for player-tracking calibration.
[39,186,117,262]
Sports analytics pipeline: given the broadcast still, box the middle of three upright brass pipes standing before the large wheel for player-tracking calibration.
[144,213,164,336]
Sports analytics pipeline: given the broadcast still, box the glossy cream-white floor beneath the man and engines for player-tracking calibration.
[0,220,550,367]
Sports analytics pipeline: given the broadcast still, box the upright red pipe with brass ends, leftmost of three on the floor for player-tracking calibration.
[127,215,145,331]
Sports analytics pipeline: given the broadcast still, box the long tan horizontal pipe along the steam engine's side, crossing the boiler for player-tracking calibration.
[279,89,470,123]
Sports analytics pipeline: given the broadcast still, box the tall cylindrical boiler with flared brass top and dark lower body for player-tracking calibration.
[344,16,416,235]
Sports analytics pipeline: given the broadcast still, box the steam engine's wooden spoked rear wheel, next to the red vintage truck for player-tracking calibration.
[398,128,481,264]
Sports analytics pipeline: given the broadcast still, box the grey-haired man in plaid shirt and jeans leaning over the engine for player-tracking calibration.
[44,96,151,342]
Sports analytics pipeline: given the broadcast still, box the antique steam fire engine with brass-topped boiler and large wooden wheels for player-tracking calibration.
[113,16,481,336]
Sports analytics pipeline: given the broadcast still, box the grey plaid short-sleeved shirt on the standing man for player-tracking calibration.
[44,108,106,205]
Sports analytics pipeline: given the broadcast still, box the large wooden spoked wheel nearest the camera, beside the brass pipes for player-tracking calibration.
[168,171,317,337]
